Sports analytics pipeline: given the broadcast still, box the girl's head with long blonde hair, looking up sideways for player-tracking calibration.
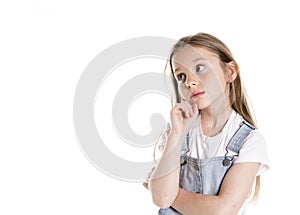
[170,33,255,125]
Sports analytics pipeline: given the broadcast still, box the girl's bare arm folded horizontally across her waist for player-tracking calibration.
[172,163,260,215]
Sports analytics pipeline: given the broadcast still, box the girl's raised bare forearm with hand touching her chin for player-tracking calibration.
[149,101,199,208]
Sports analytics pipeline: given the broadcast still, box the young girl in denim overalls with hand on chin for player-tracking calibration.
[145,33,268,215]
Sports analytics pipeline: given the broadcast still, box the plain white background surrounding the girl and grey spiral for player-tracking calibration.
[0,0,300,215]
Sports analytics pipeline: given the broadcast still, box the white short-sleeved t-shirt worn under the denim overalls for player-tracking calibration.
[158,110,269,175]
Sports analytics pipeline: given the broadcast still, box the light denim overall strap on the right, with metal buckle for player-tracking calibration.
[223,121,255,166]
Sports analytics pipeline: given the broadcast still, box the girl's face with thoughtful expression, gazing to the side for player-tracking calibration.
[172,45,232,110]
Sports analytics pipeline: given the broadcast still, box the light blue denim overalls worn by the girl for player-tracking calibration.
[158,121,254,215]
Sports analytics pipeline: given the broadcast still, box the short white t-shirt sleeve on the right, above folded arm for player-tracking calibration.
[235,130,269,175]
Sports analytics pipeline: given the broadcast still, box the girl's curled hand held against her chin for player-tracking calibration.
[171,100,199,135]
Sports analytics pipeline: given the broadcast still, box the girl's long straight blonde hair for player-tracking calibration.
[169,33,260,201]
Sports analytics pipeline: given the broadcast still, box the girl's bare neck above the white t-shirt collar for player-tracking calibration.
[200,105,233,137]
